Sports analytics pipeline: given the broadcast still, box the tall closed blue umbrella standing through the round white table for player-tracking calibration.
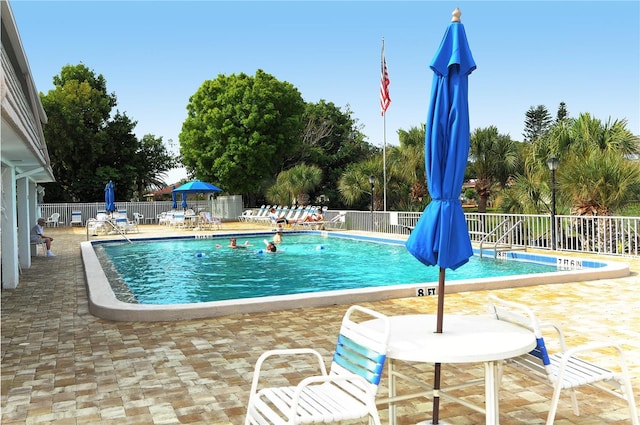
[406,8,476,424]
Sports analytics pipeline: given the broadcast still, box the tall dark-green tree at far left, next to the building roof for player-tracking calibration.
[40,64,150,202]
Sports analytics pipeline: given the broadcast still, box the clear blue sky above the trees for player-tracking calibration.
[11,0,640,181]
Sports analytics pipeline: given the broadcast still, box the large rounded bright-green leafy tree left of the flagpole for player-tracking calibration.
[180,70,305,203]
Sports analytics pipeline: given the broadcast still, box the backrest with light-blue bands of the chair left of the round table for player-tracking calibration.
[330,305,390,393]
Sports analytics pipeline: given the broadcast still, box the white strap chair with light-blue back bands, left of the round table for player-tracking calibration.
[245,306,389,425]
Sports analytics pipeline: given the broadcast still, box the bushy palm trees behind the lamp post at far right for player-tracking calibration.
[508,113,640,215]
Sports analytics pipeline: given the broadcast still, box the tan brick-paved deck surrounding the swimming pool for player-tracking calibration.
[0,223,640,425]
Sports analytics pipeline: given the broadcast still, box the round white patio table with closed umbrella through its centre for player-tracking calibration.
[365,314,536,425]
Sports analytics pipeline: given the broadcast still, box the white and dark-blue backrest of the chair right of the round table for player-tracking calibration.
[489,295,552,376]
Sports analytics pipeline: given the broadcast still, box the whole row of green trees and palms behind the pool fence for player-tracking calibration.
[40,64,640,215]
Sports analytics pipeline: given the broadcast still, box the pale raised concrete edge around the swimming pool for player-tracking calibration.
[81,232,630,322]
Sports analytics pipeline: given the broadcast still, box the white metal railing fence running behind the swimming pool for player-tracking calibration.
[40,201,640,257]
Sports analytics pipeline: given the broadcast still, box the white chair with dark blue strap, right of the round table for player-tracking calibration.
[489,295,640,425]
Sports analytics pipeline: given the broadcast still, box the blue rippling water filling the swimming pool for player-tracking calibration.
[96,235,557,304]
